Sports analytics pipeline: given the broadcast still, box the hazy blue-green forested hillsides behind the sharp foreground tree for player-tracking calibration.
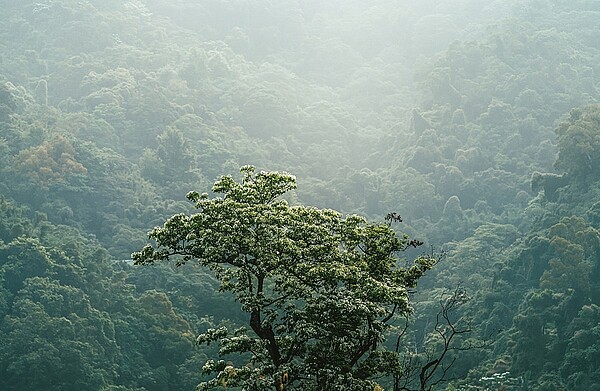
[0,0,600,391]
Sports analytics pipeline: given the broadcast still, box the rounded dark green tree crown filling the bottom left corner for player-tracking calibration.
[0,276,120,390]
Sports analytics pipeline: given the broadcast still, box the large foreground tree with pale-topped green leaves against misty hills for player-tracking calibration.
[132,166,436,391]
